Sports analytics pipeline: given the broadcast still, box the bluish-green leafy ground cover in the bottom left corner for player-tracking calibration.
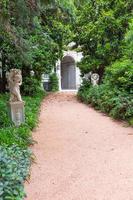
[0,145,31,200]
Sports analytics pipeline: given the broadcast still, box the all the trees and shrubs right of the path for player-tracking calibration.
[76,1,133,125]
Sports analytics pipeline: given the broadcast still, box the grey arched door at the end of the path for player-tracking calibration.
[61,56,76,90]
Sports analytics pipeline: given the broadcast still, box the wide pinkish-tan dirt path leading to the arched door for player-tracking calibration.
[26,93,133,200]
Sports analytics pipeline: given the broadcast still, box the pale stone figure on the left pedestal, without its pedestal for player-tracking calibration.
[7,69,22,102]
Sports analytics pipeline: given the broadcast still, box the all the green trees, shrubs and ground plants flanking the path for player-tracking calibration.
[0,0,133,200]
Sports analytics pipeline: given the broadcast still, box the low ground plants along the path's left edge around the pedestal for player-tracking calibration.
[0,92,45,200]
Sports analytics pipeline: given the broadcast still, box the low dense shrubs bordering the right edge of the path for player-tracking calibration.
[78,80,133,123]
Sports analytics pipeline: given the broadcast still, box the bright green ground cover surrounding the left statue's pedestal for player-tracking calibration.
[0,92,45,147]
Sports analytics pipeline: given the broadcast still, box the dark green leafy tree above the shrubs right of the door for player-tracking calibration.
[75,0,133,76]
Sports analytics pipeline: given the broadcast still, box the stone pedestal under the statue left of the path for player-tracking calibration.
[8,101,25,126]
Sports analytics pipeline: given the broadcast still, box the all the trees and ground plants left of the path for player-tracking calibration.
[0,0,73,200]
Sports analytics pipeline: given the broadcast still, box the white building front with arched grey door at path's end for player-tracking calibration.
[56,50,83,91]
